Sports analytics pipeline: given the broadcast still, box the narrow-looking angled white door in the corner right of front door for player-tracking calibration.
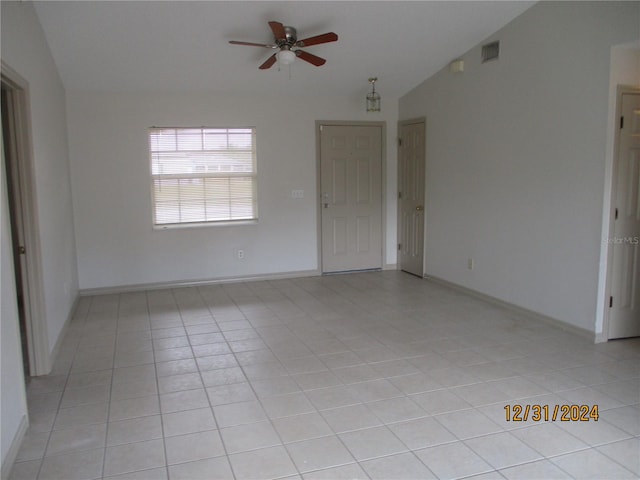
[398,121,426,277]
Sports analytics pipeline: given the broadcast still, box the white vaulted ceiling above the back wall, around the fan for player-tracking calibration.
[35,1,535,98]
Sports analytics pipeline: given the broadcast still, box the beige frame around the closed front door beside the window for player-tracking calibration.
[316,120,387,275]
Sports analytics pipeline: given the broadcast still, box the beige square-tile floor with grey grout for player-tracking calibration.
[11,272,640,480]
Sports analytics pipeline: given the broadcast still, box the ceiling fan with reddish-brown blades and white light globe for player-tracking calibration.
[229,22,338,70]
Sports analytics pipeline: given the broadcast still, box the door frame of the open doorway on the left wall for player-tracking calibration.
[0,62,51,376]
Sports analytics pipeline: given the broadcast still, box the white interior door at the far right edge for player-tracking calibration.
[608,93,640,339]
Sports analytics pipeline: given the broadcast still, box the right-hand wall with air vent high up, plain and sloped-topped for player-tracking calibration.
[400,2,640,332]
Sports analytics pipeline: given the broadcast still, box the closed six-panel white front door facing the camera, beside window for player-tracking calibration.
[320,125,382,273]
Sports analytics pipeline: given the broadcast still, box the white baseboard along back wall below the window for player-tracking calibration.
[79,270,321,297]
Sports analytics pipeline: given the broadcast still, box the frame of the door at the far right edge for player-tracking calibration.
[596,85,640,341]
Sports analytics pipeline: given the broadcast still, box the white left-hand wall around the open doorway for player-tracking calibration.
[0,1,78,463]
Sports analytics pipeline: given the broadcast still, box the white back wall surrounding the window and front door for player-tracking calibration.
[67,92,397,289]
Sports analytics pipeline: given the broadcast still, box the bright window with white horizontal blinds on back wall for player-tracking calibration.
[149,127,258,226]
